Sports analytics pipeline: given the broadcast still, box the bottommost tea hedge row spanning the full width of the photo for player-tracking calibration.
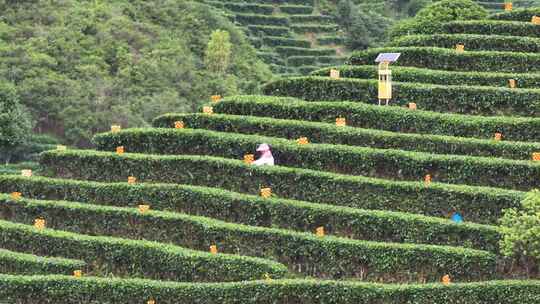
[0,275,540,304]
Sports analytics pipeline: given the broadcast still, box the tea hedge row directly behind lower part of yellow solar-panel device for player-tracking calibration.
[264,76,540,116]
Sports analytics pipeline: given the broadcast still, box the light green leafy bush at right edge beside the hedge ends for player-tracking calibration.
[500,190,540,276]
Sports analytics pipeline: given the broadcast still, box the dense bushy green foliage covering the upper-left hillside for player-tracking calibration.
[0,0,270,145]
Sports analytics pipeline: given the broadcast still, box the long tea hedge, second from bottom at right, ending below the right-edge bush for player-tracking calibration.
[0,196,495,282]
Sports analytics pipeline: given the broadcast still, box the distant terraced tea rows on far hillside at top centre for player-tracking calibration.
[204,0,346,75]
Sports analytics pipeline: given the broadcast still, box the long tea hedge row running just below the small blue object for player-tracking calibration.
[0,176,499,252]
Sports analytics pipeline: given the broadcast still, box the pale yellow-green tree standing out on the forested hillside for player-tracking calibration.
[204,30,232,75]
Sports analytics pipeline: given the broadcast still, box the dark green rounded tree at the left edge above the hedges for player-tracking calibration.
[0,81,32,164]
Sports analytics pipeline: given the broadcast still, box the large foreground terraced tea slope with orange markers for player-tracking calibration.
[0,4,540,304]
